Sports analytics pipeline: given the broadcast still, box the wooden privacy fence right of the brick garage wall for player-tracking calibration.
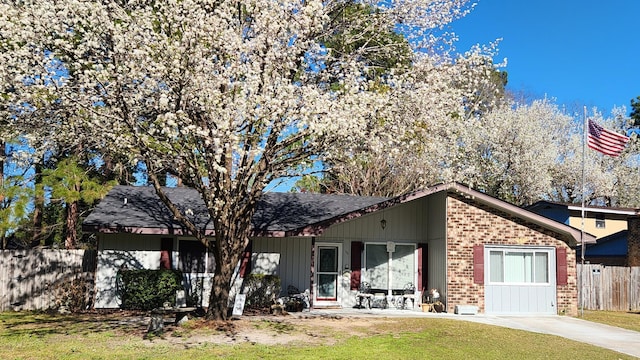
[578,264,640,311]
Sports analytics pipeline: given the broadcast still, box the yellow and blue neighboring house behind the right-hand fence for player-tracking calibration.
[527,201,637,266]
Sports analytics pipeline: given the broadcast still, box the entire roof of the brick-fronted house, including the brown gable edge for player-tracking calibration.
[82,183,595,245]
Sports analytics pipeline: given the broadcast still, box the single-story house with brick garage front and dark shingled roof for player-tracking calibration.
[83,183,595,314]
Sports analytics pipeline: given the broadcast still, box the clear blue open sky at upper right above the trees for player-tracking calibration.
[450,0,640,116]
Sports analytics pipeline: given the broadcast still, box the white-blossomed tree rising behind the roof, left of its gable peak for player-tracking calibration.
[314,49,505,196]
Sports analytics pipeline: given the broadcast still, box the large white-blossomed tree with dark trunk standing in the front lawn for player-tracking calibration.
[0,0,496,318]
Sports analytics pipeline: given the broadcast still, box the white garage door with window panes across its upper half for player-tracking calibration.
[484,246,557,315]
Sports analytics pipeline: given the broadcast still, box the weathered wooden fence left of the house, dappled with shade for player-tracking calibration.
[0,249,96,311]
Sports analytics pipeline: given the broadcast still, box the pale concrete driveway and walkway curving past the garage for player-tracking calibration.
[304,309,640,359]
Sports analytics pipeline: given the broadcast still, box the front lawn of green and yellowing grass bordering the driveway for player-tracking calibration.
[0,312,640,359]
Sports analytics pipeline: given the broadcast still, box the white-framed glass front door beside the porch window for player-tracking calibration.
[315,244,341,305]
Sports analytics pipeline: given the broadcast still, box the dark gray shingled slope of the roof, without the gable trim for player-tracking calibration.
[83,186,387,234]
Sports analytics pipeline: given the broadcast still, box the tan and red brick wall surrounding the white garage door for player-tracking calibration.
[446,194,578,315]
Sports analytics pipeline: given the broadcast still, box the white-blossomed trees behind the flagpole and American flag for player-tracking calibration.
[459,99,640,207]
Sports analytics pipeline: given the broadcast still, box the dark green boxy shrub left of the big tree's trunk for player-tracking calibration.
[118,270,183,310]
